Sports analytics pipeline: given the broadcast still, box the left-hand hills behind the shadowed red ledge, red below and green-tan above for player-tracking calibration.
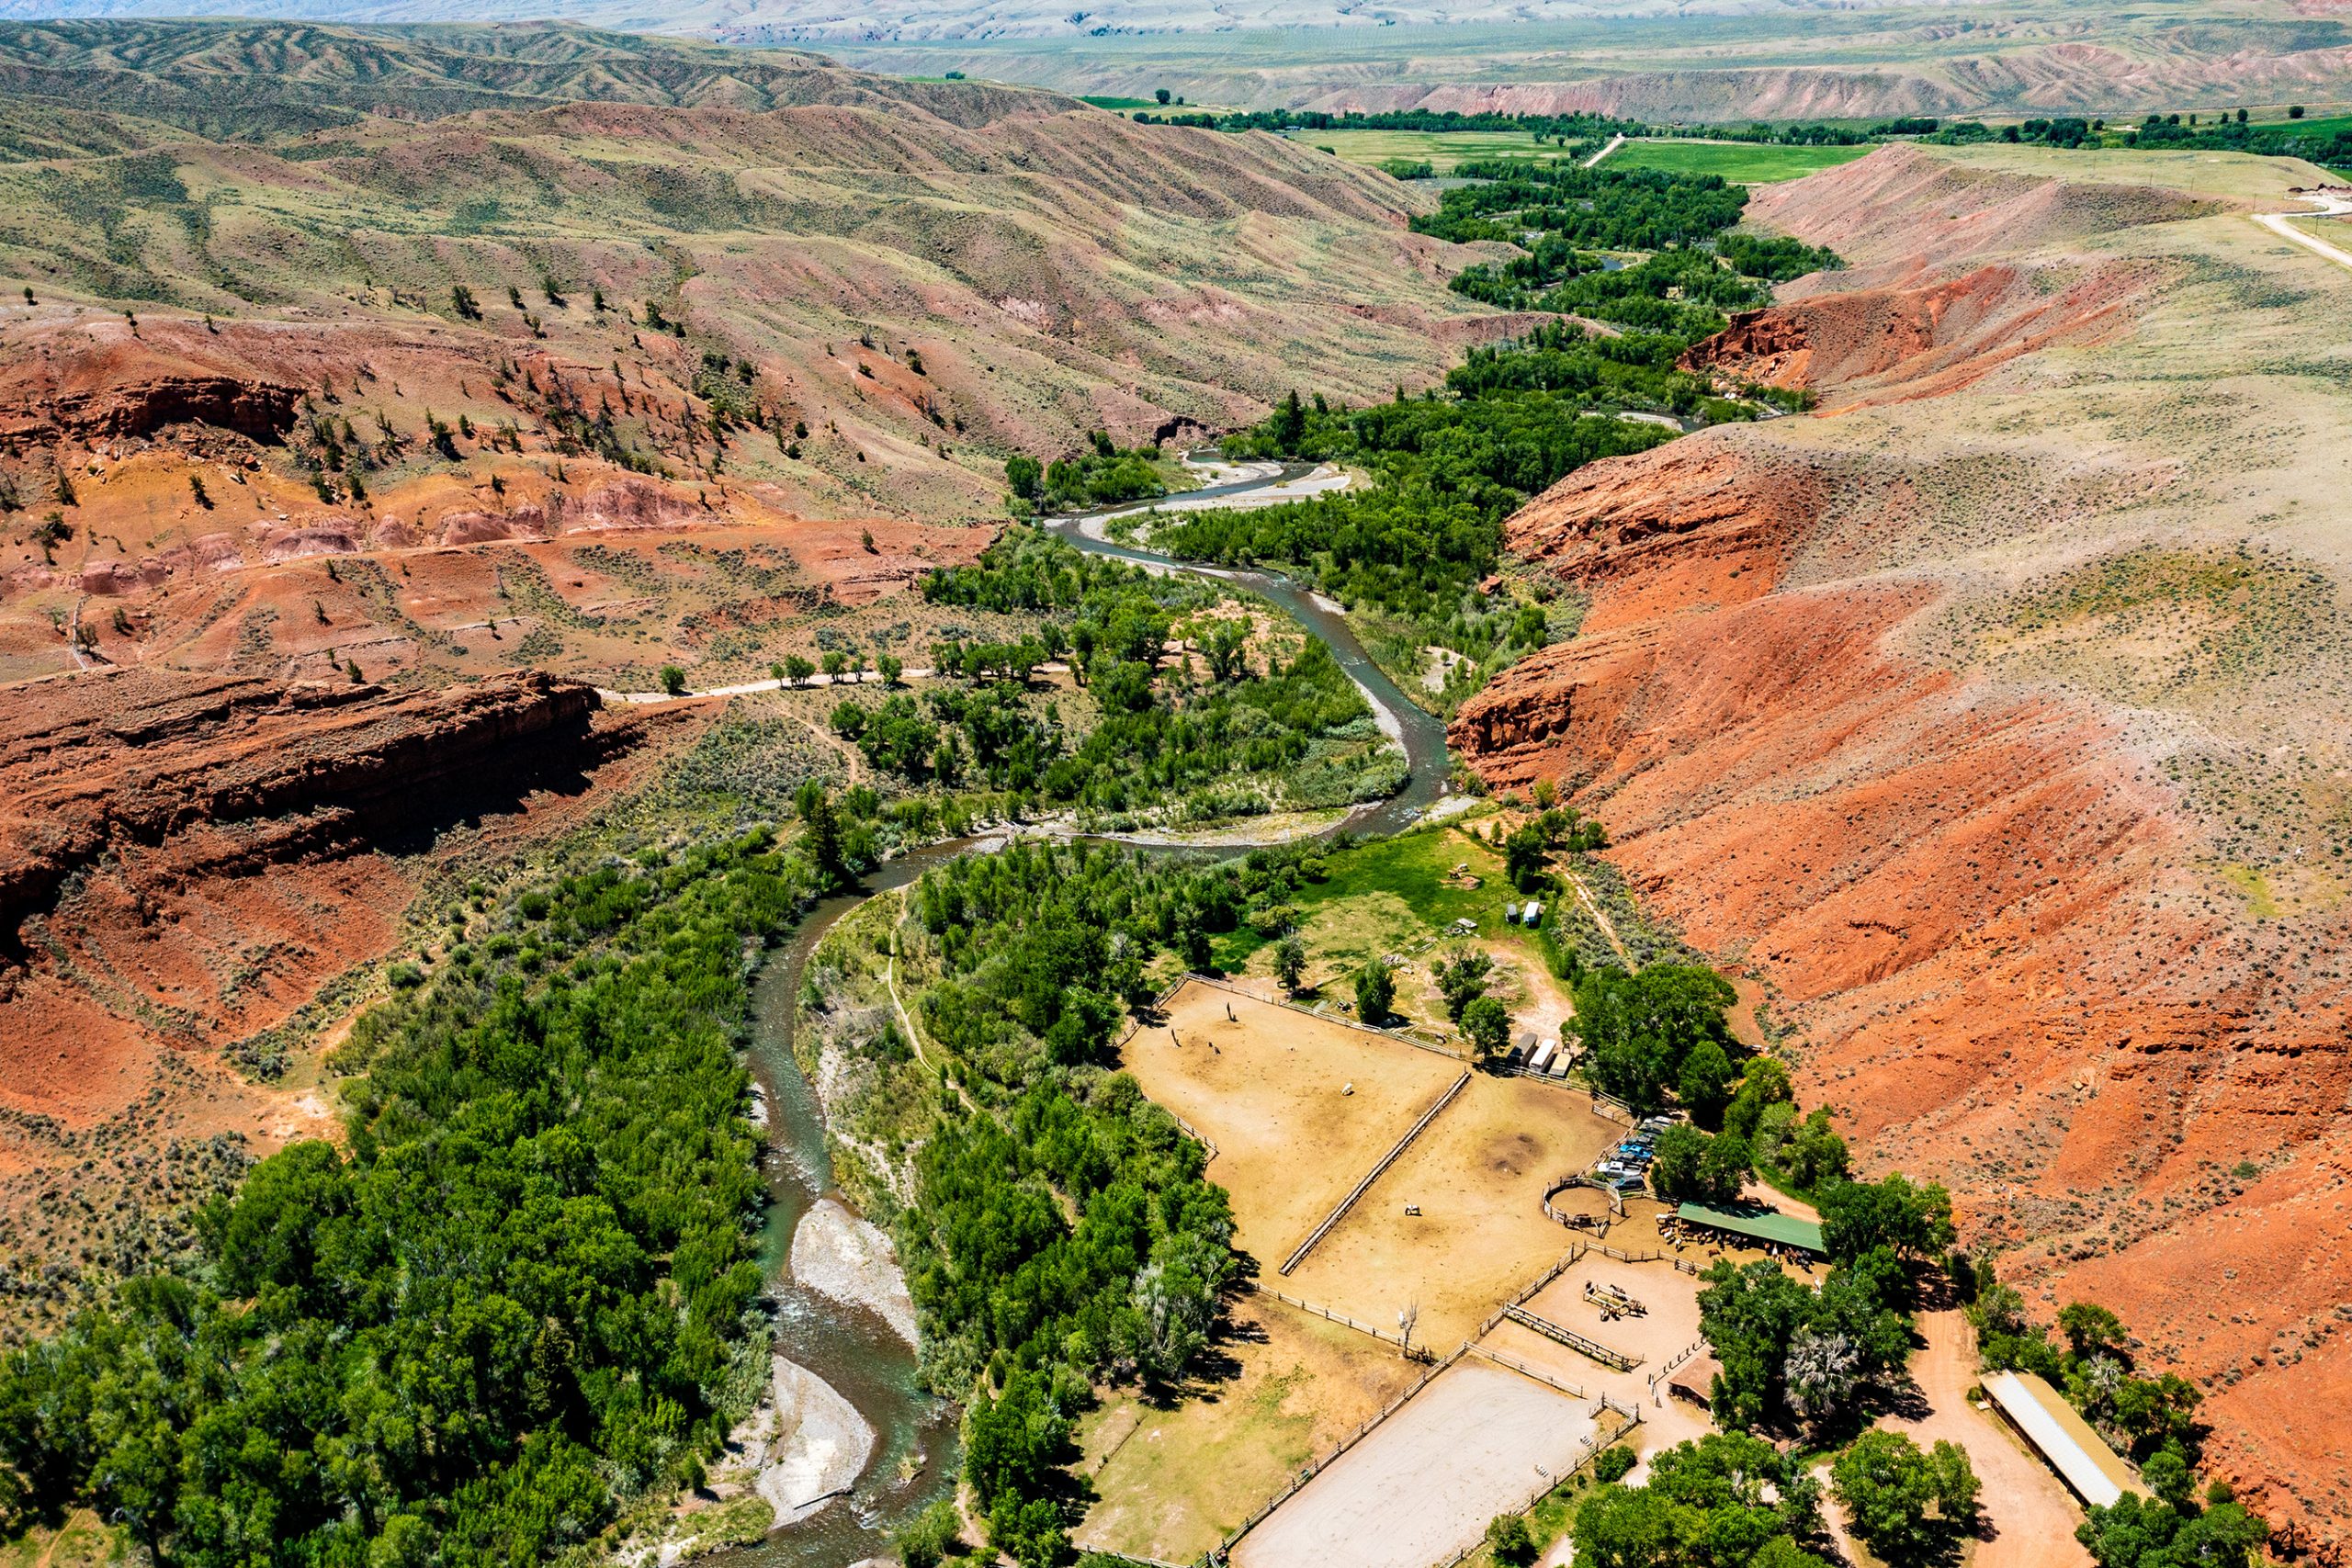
[0,51,1477,689]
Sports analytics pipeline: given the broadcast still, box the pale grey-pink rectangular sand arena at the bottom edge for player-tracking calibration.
[1232,1357,1592,1568]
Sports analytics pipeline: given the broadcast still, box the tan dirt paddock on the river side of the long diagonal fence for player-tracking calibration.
[1125,983,1467,1259]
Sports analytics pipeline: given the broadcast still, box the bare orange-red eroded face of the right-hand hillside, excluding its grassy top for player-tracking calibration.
[1453,151,2352,1550]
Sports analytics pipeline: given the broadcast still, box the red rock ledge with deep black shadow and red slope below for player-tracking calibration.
[0,670,628,1133]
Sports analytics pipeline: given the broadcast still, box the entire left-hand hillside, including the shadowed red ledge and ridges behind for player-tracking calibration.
[0,42,1482,1336]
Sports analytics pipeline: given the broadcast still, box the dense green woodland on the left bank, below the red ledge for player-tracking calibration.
[0,829,840,1568]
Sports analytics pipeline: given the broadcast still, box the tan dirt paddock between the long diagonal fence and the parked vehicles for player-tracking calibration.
[1284,1075,1621,1349]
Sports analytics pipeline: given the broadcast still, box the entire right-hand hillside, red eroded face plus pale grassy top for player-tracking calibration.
[1453,148,2352,1540]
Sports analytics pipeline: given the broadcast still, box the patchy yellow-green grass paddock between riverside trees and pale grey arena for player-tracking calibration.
[1077,1298,1420,1563]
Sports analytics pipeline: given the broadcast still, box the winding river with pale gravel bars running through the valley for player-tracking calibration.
[706,463,1449,1568]
